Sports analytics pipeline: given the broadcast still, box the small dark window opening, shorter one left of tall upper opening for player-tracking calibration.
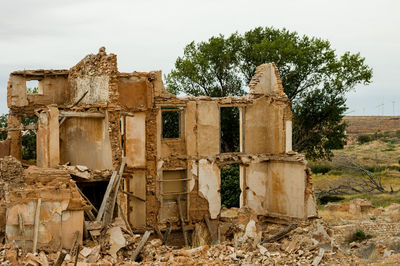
[161,108,182,139]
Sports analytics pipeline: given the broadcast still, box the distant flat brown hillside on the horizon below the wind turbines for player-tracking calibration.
[343,116,400,135]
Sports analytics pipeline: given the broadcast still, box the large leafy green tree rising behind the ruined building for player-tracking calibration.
[166,27,372,158]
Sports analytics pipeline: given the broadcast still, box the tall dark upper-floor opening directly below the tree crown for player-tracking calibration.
[220,107,240,153]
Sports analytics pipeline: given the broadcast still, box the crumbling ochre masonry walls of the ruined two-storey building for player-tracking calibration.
[0,48,317,239]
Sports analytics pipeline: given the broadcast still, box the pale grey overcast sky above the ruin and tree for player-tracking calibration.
[0,0,400,115]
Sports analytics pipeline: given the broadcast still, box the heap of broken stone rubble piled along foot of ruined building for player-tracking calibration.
[0,209,359,265]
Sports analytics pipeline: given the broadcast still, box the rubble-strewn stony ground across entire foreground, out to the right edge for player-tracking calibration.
[0,200,400,265]
